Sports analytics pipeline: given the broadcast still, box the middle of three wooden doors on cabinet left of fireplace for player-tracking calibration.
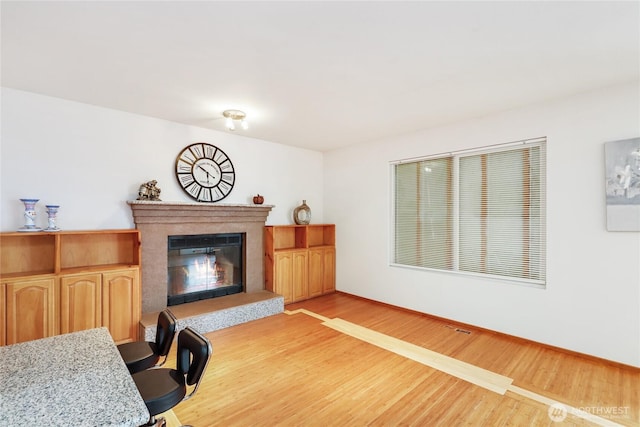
[60,273,102,334]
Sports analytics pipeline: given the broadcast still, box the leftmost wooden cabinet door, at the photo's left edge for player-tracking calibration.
[5,278,56,344]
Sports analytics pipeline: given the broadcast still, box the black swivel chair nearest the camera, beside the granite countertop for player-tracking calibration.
[132,327,213,426]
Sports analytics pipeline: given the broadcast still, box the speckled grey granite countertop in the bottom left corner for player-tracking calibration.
[0,328,149,427]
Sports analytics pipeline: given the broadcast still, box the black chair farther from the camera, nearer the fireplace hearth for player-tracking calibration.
[118,309,178,374]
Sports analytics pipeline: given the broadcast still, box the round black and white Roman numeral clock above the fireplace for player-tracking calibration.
[176,142,236,202]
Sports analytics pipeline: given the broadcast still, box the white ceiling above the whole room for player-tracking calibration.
[0,1,640,151]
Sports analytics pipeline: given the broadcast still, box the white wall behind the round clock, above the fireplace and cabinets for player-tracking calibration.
[0,88,323,231]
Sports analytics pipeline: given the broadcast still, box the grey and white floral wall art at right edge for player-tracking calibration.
[604,138,640,231]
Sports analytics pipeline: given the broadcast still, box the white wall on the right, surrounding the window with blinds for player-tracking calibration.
[324,83,640,366]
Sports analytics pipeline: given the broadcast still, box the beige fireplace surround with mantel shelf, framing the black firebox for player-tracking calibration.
[127,200,273,313]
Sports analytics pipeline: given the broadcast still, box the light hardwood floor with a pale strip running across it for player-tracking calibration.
[167,294,640,427]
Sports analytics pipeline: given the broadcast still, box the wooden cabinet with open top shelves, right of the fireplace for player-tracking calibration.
[265,224,336,304]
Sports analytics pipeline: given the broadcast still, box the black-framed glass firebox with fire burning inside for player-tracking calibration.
[167,233,245,306]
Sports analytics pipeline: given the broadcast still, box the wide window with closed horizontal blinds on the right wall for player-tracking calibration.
[392,138,546,285]
